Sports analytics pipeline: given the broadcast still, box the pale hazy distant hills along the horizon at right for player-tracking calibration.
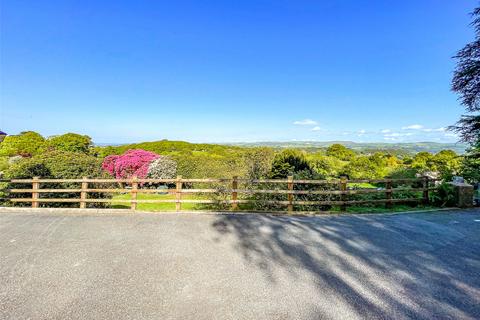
[226,141,467,154]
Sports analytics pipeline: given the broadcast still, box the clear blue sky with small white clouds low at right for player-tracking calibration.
[0,0,478,143]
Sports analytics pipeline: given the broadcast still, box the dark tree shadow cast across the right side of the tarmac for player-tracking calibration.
[213,211,480,319]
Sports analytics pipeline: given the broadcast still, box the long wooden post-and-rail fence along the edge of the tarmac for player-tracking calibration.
[0,176,435,213]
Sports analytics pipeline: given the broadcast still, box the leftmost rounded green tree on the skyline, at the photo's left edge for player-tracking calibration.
[0,131,45,157]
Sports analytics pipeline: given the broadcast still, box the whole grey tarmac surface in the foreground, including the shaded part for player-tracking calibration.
[0,209,480,320]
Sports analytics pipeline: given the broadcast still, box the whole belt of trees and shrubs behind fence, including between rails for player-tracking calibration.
[0,132,472,210]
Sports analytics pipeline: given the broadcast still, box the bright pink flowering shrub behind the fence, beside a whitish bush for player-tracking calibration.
[102,149,160,179]
